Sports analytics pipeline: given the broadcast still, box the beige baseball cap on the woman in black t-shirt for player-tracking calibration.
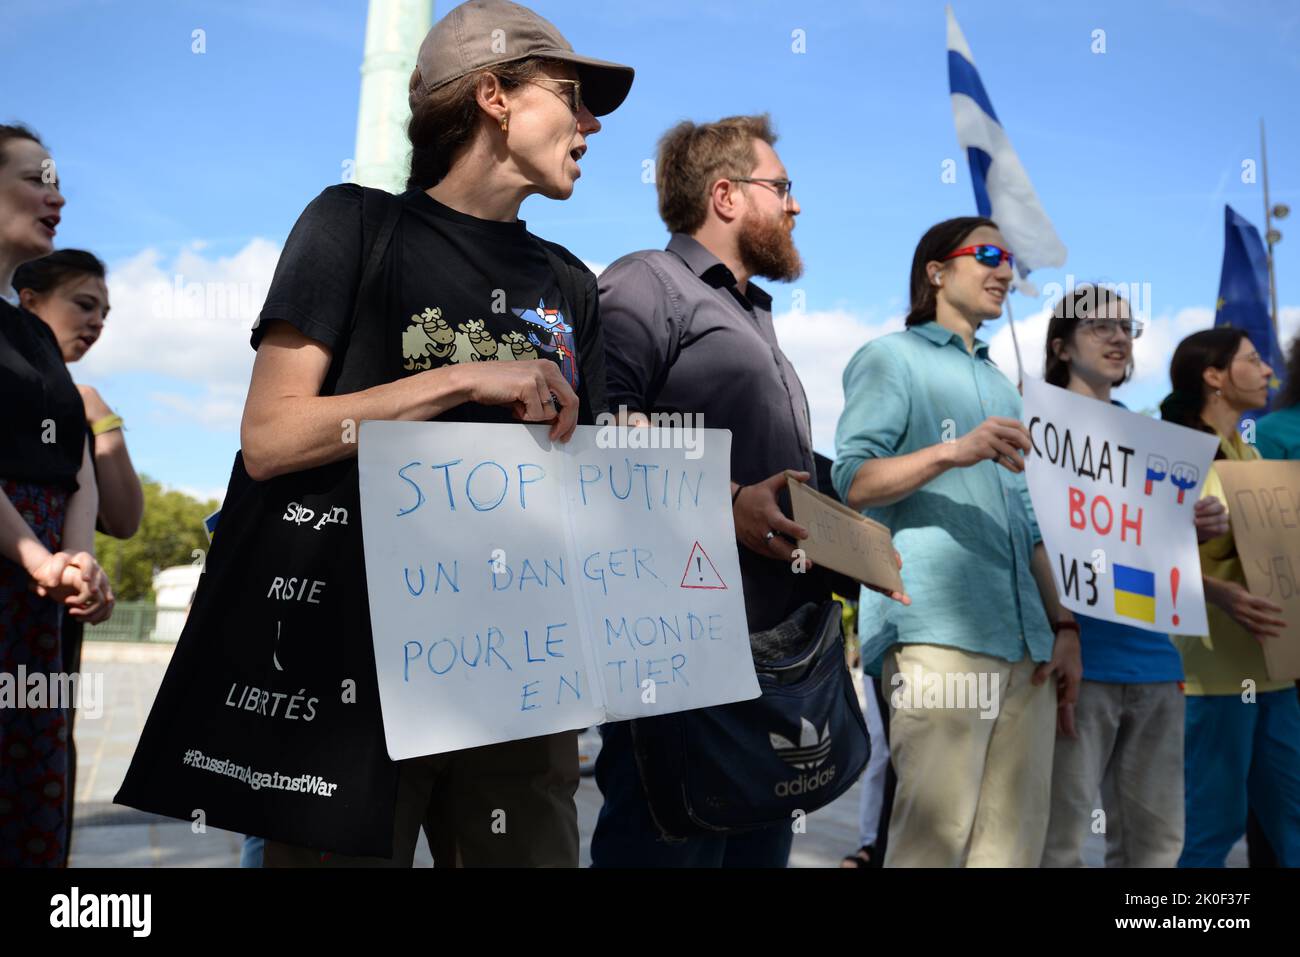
[411,0,634,116]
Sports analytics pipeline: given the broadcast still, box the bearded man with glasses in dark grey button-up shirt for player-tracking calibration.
[592,116,852,867]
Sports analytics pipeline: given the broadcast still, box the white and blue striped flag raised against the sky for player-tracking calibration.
[948,7,1065,280]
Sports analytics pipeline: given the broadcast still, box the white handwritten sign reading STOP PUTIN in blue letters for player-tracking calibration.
[359,421,758,759]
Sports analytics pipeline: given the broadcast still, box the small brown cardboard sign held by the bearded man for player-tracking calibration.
[785,473,904,592]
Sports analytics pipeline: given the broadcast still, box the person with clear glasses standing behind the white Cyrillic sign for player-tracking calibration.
[1043,283,1229,867]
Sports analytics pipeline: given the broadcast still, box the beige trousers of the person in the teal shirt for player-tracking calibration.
[881,644,1057,867]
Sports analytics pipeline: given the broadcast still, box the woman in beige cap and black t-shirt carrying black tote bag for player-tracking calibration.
[118,0,633,867]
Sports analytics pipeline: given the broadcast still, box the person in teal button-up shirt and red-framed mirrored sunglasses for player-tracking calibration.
[832,217,1080,867]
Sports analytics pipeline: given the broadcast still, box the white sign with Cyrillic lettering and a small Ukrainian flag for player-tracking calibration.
[1024,378,1218,635]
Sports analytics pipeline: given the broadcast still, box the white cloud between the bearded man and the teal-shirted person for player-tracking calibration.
[772,309,904,458]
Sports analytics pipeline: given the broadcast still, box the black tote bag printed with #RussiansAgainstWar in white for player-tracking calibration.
[114,189,402,857]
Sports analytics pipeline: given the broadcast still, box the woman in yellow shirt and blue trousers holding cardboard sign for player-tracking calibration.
[1160,326,1300,867]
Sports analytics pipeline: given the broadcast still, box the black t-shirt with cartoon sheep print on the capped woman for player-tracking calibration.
[252,185,605,424]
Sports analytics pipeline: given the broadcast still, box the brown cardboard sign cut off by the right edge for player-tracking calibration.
[1214,460,1300,681]
